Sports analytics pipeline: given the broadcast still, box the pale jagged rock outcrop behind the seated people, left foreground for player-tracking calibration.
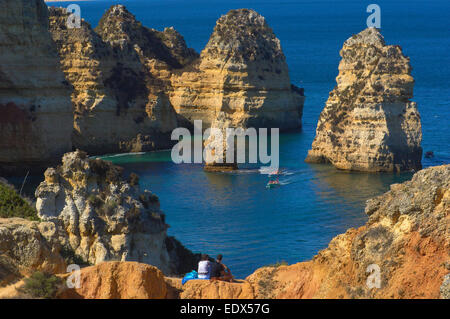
[36,151,197,274]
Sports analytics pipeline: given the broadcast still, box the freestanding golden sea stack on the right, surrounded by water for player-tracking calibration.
[306,28,422,172]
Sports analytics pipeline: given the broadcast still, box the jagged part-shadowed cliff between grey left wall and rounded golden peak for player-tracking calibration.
[50,5,184,154]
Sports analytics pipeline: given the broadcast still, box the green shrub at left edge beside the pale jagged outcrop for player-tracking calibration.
[0,183,39,221]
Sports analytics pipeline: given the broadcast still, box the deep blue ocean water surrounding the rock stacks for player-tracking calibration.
[49,0,450,278]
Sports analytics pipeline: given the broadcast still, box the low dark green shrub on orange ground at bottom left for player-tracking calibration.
[21,271,63,299]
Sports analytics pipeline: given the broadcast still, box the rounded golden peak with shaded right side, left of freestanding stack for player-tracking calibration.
[169,9,304,130]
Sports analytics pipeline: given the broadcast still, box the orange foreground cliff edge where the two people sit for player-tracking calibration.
[0,165,450,299]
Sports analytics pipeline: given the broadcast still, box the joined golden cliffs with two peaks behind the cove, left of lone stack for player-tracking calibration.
[44,5,304,158]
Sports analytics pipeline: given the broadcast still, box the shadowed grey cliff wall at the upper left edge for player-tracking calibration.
[0,0,73,173]
